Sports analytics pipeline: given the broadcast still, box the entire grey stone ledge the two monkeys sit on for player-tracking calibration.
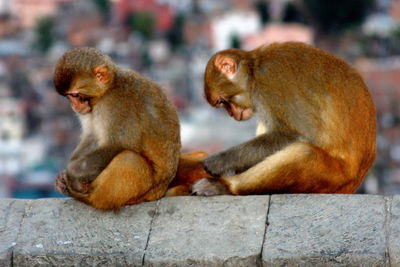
[0,195,400,267]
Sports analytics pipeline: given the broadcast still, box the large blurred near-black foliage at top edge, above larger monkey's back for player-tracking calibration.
[303,0,374,33]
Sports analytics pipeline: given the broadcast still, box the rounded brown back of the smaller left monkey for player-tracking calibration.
[97,70,181,182]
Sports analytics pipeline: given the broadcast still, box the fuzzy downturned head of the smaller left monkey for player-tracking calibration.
[54,47,116,114]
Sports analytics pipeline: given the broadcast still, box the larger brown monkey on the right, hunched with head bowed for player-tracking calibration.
[193,42,376,195]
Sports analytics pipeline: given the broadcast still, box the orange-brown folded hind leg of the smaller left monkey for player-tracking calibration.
[87,150,168,210]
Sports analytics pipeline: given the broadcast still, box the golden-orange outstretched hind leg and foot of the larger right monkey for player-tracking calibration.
[193,142,361,195]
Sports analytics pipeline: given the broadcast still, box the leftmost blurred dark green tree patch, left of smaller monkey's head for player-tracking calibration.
[33,17,55,53]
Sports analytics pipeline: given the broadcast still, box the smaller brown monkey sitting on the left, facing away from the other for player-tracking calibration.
[54,47,182,210]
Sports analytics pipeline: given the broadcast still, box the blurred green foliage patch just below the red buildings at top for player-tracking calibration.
[128,11,156,40]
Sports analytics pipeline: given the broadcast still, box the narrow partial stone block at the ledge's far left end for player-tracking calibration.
[0,199,26,266]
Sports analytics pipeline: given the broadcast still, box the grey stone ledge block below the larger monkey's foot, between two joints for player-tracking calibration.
[145,196,269,266]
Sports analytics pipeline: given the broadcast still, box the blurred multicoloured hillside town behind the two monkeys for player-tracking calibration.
[0,0,400,198]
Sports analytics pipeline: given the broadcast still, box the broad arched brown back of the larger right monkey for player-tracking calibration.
[252,42,376,182]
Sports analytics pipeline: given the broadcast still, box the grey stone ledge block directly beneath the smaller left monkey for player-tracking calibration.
[13,199,157,266]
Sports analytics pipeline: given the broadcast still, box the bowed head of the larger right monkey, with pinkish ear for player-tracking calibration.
[204,49,254,121]
